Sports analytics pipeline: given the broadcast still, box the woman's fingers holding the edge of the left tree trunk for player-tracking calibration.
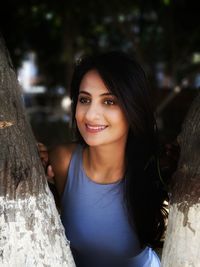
[37,143,55,182]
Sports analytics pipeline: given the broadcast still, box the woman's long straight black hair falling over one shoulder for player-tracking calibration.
[71,51,166,247]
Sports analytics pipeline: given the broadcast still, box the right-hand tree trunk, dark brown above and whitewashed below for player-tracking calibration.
[161,94,200,267]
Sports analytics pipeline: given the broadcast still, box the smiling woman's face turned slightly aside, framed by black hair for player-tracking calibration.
[75,70,129,146]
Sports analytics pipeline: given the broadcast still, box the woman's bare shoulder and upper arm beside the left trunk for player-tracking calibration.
[49,143,77,195]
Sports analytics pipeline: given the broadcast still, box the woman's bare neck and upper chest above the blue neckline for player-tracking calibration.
[83,146,125,184]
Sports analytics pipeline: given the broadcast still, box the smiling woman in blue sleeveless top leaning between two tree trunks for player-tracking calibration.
[40,52,166,267]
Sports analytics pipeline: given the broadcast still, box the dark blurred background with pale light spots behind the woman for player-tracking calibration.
[0,0,200,149]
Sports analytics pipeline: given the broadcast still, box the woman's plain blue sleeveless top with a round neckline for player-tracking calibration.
[61,145,160,267]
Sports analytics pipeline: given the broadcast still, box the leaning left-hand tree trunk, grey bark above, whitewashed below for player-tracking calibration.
[0,37,75,267]
